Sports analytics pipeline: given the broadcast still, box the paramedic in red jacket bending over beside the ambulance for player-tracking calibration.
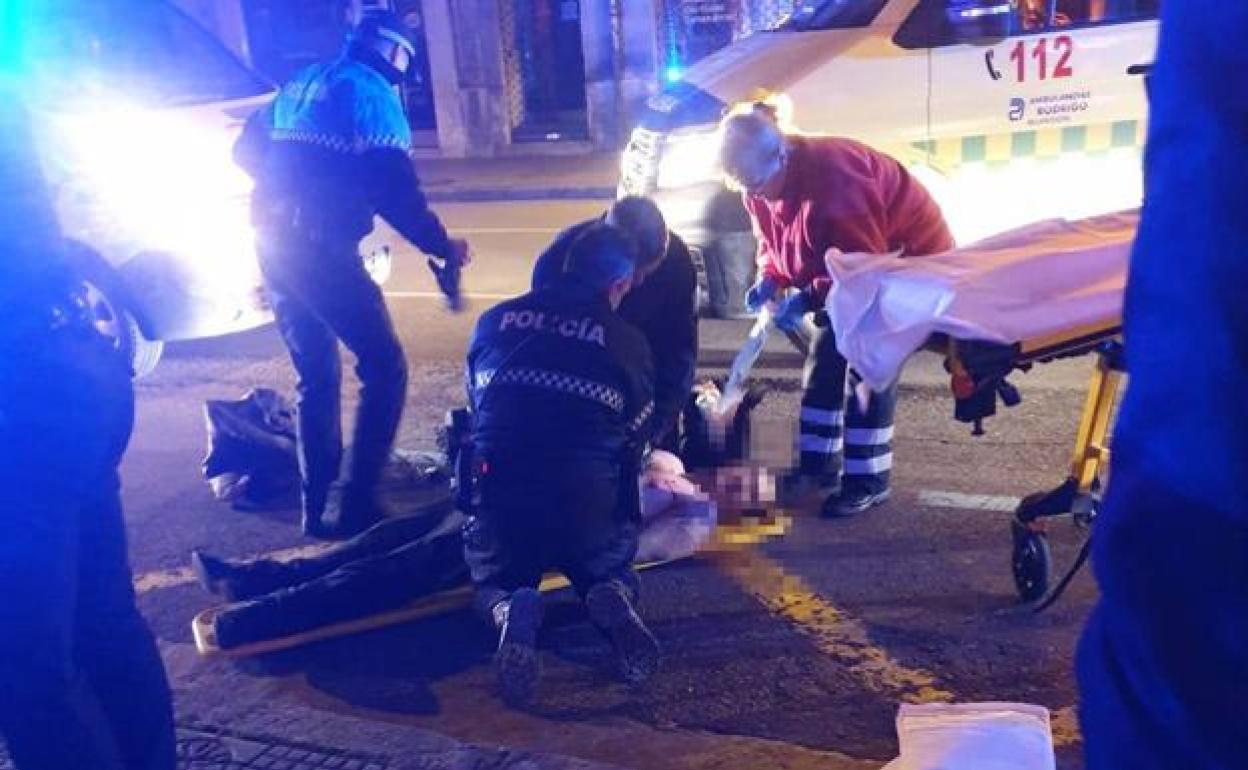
[721,105,953,517]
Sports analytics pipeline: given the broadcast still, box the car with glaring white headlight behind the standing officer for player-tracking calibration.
[12,0,389,374]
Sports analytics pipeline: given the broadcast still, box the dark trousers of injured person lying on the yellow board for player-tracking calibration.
[216,510,468,649]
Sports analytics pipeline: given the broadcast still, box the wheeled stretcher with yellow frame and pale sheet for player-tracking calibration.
[825,212,1138,610]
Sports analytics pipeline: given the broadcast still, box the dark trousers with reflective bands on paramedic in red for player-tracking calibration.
[799,326,897,493]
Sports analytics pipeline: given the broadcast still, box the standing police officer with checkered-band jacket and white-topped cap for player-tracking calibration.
[235,11,468,535]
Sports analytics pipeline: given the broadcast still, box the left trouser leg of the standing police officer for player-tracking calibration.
[262,252,342,537]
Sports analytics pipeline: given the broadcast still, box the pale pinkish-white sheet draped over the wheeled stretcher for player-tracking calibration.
[825,211,1139,389]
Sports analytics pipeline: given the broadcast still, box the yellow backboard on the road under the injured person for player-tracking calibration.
[191,512,791,658]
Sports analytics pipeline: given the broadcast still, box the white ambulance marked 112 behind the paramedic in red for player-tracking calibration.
[619,0,1159,317]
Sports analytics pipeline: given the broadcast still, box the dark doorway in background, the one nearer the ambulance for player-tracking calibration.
[502,0,588,142]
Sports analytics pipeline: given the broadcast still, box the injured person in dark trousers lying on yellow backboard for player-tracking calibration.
[183,452,716,649]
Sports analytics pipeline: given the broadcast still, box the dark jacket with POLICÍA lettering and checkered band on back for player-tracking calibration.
[467,276,654,467]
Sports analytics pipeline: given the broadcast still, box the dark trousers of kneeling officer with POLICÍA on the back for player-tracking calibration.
[464,461,639,618]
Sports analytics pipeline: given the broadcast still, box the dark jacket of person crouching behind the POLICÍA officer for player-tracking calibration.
[533,220,698,437]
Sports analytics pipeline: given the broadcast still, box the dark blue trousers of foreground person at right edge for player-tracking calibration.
[1078,464,1248,770]
